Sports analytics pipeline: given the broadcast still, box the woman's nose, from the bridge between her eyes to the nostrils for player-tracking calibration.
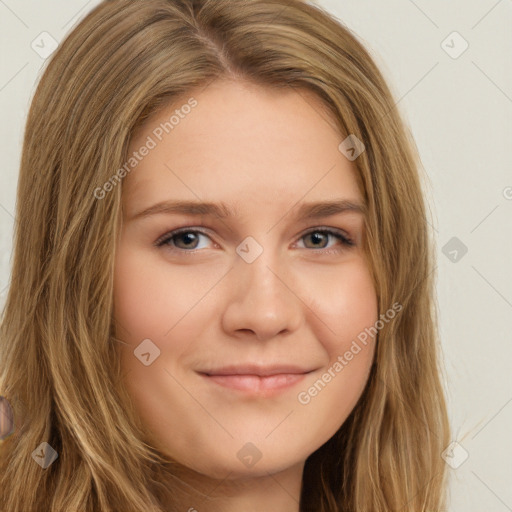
[224,237,301,340]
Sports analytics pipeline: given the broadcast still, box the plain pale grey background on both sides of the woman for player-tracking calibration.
[0,0,512,512]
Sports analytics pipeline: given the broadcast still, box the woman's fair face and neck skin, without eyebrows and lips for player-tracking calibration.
[114,80,378,512]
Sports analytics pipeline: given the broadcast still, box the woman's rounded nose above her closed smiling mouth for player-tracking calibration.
[222,245,305,341]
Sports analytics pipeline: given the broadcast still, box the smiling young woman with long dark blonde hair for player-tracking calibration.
[0,0,449,512]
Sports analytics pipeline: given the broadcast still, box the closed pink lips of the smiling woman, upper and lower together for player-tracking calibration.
[198,365,313,396]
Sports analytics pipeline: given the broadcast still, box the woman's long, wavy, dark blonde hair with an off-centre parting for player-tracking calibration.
[0,0,449,512]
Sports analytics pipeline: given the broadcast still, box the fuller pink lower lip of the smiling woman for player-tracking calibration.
[201,373,306,396]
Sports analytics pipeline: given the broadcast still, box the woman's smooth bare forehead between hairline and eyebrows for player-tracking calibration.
[123,80,361,215]
